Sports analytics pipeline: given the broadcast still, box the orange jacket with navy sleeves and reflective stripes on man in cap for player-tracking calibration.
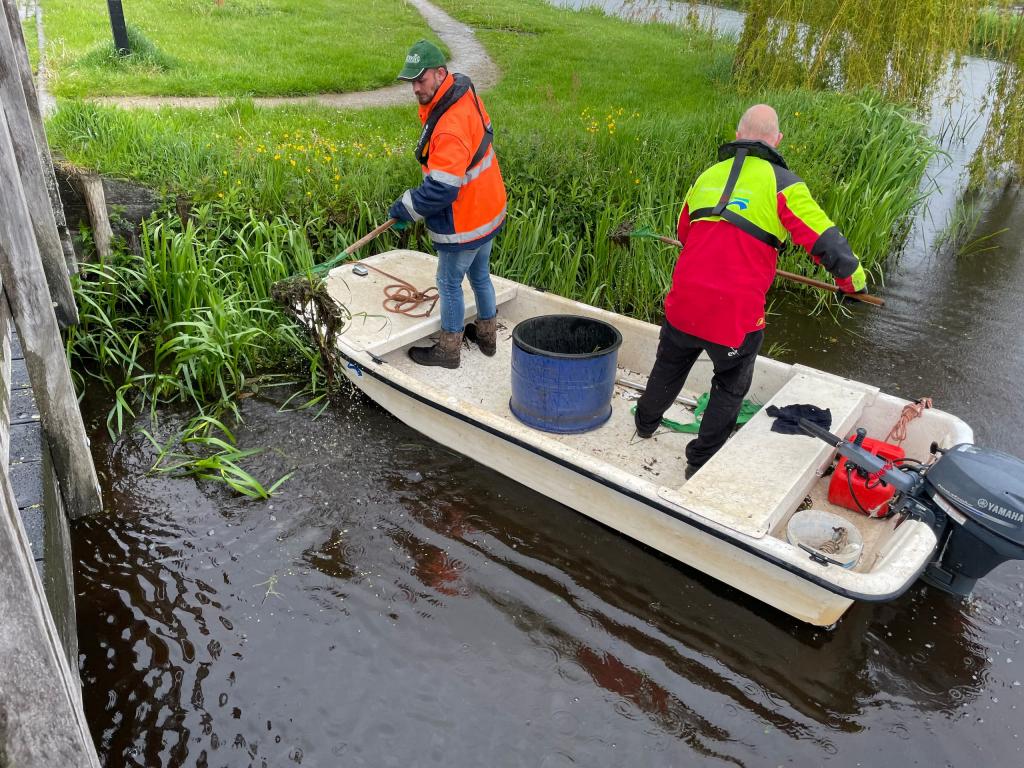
[388,74,506,251]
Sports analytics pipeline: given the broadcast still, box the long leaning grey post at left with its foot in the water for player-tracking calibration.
[0,110,102,518]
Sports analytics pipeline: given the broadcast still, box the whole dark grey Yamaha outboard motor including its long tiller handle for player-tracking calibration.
[800,419,1024,597]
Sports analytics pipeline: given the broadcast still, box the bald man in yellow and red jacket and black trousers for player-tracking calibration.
[636,104,865,477]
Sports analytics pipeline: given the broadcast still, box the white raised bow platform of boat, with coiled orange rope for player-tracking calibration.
[327,251,517,356]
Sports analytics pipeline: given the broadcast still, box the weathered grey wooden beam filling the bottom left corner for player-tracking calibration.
[0,460,99,768]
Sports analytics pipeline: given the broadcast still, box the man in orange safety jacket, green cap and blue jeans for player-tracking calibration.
[388,40,506,368]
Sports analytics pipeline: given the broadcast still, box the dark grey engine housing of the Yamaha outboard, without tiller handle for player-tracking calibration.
[922,443,1024,596]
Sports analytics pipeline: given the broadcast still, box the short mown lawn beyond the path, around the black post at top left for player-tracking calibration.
[43,0,436,97]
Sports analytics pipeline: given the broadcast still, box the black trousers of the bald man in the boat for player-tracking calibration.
[636,321,765,467]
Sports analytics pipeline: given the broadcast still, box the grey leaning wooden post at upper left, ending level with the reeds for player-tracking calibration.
[0,14,78,327]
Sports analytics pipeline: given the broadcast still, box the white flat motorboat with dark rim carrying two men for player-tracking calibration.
[307,250,973,627]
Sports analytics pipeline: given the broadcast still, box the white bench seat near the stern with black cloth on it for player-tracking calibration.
[658,366,879,539]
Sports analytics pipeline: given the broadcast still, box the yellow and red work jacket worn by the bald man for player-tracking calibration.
[665,141,863,347]
